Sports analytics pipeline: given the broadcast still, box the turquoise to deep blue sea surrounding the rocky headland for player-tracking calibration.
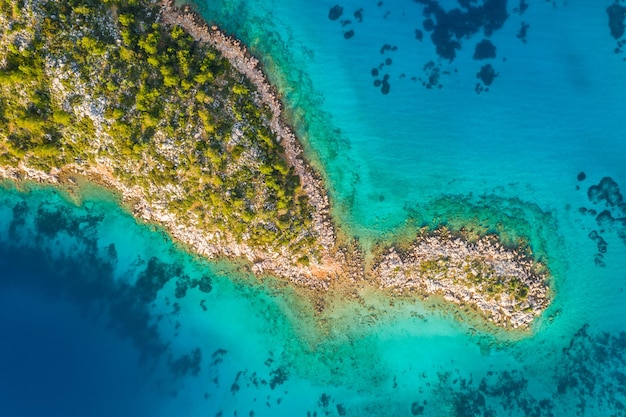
[0,0,626,417]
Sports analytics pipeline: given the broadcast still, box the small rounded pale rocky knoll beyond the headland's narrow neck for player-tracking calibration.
[373,230,550,328]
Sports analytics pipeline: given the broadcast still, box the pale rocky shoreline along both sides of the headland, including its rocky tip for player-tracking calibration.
[0,0,550,328]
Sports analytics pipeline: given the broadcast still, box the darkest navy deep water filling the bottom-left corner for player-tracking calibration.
[0,288,158,417]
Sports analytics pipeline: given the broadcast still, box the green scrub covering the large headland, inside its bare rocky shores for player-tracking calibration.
[0,0,315,256]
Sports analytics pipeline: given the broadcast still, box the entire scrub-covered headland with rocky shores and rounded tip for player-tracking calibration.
[0,0,553,328]
